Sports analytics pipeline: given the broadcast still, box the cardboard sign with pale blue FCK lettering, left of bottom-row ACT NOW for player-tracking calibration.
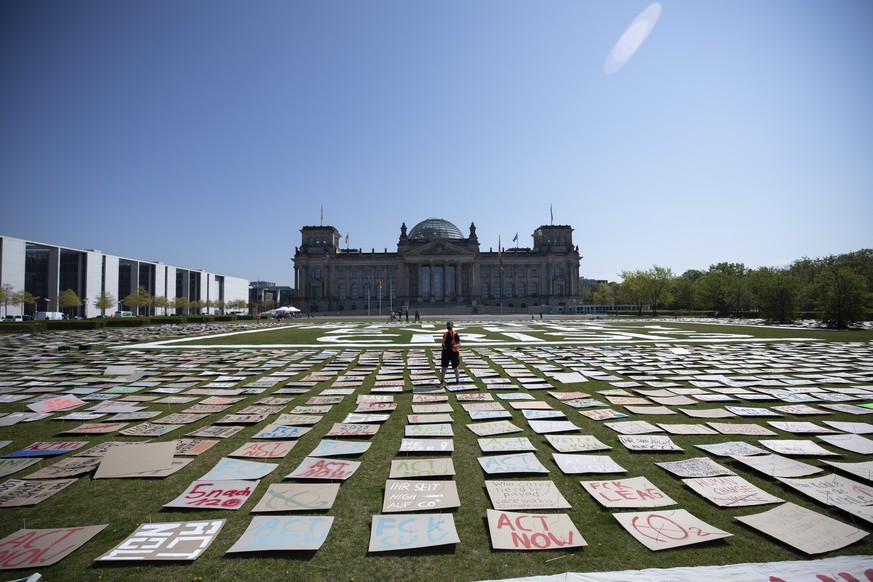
[369,513,461,552]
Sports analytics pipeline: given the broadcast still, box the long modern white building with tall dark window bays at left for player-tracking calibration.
[0,235,249,317]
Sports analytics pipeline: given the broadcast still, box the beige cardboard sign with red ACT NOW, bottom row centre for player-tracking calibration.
[488,509,588,550]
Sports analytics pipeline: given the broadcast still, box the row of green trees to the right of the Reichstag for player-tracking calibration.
[583,249,873,328]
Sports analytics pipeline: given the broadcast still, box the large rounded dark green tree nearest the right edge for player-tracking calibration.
[813,266,867,328]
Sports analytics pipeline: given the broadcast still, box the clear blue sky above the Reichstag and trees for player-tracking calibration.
[0,0,873,285]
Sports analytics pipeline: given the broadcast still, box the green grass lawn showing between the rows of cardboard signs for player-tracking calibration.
[0,321,873,582]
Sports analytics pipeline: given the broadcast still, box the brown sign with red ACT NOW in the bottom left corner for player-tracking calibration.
[0,524,106,570]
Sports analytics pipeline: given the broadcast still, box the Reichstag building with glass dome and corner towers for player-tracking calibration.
[294,218,580,313]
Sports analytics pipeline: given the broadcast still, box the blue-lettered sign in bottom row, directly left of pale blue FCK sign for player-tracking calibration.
[227,516,333,554]
